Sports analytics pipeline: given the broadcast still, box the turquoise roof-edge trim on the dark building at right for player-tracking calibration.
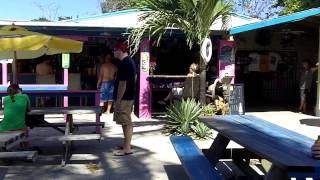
[230,8,320,35]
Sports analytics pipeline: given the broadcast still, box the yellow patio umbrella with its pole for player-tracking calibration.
[0,25,83,82]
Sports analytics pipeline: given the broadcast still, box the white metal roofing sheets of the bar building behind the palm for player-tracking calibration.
[0,9,260,31]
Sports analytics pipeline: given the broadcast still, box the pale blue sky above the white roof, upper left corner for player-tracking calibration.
[0,0,101,20]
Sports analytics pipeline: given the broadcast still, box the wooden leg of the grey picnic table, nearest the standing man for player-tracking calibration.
[61,114,73,166]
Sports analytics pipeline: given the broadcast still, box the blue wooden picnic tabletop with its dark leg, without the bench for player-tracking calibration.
[200,115,320,179]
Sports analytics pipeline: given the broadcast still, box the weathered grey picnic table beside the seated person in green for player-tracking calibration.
[0,106,102,166]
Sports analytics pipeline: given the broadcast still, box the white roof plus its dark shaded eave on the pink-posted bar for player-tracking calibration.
[0,9,260,36]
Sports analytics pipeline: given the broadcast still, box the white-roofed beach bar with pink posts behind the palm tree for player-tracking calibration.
[0,10,259,118]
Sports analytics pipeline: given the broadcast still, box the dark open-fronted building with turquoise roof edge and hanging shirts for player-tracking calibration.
[230,8,320,115]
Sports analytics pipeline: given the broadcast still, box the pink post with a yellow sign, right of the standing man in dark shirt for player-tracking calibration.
[138,39,151,119]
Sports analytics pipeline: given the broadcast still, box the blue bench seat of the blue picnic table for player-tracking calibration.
[170,136,223,180]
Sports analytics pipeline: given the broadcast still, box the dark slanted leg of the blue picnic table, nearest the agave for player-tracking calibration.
[203,133,230,166]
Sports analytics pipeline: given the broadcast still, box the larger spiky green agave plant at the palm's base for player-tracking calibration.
[165,98,201,135]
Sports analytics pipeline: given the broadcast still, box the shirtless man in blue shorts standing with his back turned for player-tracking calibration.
[97,53,117,114]
